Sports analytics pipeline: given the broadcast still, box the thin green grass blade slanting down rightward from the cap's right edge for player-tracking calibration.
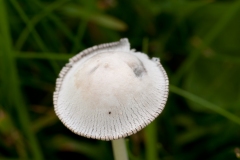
[170,85,240,125]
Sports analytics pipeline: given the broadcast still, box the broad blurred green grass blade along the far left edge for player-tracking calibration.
[0,0,43,160]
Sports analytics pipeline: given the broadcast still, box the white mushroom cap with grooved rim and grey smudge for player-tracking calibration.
[54,39,168,140]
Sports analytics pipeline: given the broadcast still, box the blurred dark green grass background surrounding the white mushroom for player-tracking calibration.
[0,0,240,160]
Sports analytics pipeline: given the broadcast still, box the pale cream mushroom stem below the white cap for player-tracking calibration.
[112,138,128,160]
